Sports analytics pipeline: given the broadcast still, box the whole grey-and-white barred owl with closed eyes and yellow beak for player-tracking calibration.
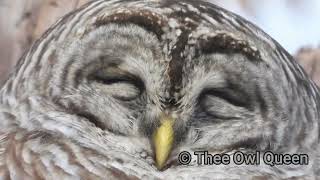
[0,0,319,179]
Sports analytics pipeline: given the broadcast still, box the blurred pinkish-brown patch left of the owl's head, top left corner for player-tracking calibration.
[0,0,90,82]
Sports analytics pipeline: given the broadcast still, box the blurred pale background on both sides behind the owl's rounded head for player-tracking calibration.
[0,0,320,85]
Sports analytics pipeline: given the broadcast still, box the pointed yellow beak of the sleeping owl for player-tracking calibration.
[153,115,174,170]
